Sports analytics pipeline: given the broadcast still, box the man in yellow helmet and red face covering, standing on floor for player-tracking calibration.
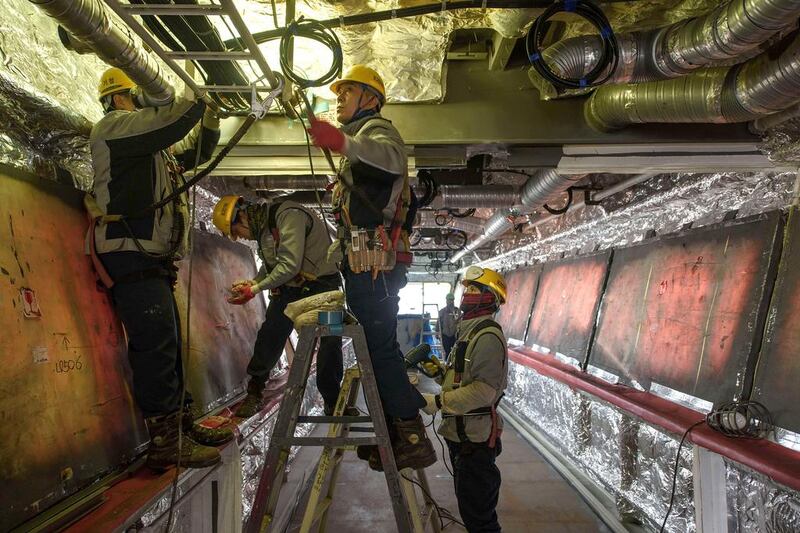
[423,266,508,531]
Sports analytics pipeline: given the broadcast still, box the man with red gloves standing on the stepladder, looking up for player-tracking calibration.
[309,65,436,469]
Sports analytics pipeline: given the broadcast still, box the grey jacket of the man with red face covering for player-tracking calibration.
[439,316,508,442]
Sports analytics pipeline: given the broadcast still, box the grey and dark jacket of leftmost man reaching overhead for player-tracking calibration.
[87,98,219,256]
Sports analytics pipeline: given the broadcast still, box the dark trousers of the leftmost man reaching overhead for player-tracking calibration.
[101,252,188,417]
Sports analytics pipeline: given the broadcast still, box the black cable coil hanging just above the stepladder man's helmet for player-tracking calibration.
[280,17,343,89]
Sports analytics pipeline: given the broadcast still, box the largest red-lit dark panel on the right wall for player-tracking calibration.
[590,212,783,403]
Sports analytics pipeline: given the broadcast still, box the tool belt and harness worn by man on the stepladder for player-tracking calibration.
[331,117,414,278]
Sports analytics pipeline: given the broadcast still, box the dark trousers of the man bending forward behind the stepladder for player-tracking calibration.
[247,275,344,407]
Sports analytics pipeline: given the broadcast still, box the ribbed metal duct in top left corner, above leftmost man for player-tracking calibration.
[30,0,174,103]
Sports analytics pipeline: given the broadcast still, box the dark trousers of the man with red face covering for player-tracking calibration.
[445,439,502,533]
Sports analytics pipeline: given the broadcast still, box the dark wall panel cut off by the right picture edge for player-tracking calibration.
[752,208,800,433]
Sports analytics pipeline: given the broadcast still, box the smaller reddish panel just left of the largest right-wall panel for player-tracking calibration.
[525,251,611,362]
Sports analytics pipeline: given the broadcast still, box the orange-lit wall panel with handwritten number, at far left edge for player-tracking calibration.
[0,167,147,531]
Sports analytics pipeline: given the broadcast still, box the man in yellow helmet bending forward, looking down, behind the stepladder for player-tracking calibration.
[213,196,343,418]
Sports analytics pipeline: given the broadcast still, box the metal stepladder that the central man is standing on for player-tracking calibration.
[246,324,439,533]
